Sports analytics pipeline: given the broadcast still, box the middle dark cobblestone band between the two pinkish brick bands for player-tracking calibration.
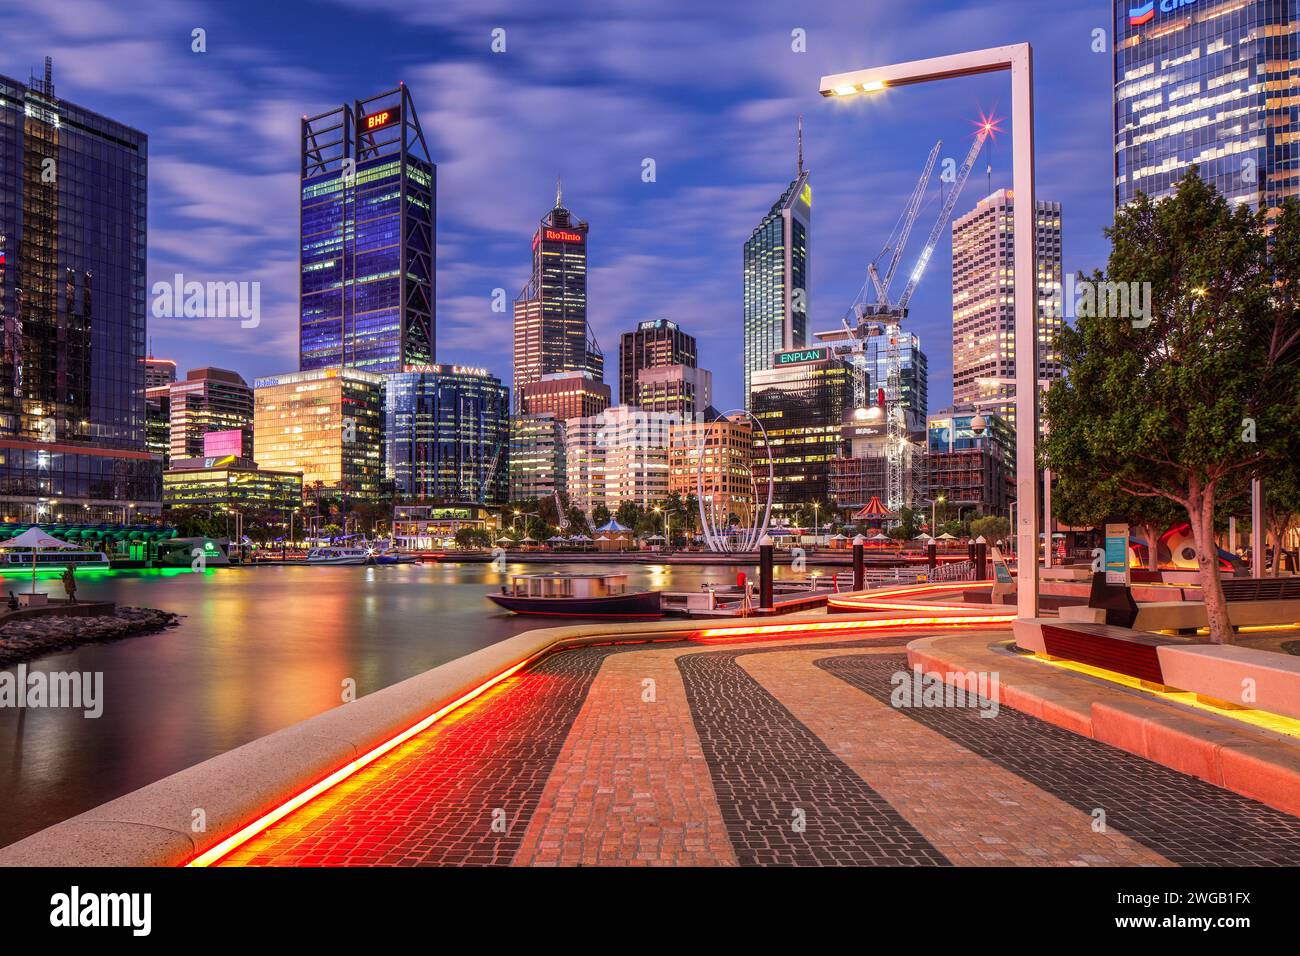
[677,645,948,866]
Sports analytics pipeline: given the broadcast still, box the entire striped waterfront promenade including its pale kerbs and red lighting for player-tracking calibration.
[0,585,1300,866]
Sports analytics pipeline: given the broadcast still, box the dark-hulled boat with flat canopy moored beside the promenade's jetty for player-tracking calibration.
[486,574,663,618]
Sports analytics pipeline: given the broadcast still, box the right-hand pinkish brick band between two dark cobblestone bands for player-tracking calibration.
[738,644,1171,866]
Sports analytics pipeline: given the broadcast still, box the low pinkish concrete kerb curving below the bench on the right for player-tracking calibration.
[907,631,1300,817]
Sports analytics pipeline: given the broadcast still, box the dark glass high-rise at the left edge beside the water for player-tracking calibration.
[0,57,163,520]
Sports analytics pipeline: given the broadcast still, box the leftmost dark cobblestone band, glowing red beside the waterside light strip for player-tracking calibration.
[222,648,611,866]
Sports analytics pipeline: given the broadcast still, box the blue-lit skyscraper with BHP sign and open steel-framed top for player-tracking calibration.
[298,85,437,372]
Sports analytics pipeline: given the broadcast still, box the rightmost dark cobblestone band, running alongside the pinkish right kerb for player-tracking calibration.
[815,654,1300,866]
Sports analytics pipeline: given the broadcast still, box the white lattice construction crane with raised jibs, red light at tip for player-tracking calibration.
[837,117,997,514]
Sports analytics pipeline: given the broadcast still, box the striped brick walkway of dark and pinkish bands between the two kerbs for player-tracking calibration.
[222,632,1300,866]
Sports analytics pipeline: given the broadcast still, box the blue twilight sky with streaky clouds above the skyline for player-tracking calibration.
[0,0,1113,408]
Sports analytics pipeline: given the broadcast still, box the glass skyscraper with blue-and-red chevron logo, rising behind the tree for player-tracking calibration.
[1114,0,1300,209]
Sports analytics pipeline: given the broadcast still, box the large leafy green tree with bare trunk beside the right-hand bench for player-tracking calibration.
[1045,169,1300,644]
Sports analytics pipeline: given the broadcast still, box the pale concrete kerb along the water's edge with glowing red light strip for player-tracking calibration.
[0,611,888,866]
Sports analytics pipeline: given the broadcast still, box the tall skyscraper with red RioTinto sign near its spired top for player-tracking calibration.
[515,185,605,407]
